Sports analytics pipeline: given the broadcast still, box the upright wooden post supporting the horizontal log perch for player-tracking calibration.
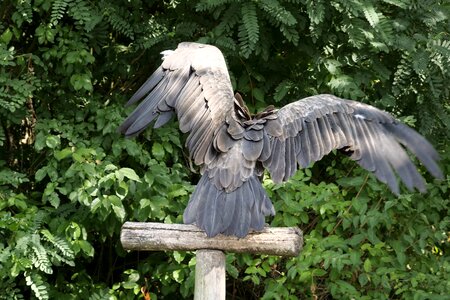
[194,250,226,300]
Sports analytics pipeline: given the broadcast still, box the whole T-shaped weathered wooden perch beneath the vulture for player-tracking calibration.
[120,222,303,300]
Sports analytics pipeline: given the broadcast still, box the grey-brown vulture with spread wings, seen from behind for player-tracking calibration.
[119,42,443,237]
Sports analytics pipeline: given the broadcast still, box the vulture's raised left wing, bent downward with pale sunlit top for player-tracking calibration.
[119,43,234,165]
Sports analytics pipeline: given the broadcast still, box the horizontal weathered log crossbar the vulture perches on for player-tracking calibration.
[120,222,303,256]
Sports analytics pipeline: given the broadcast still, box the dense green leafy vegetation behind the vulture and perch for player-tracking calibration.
[0,0,450,299]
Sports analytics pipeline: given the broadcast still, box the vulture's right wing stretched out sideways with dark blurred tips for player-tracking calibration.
[263,95,442,194]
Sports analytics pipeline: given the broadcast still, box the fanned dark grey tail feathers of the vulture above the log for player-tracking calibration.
[183,172,275,237]
